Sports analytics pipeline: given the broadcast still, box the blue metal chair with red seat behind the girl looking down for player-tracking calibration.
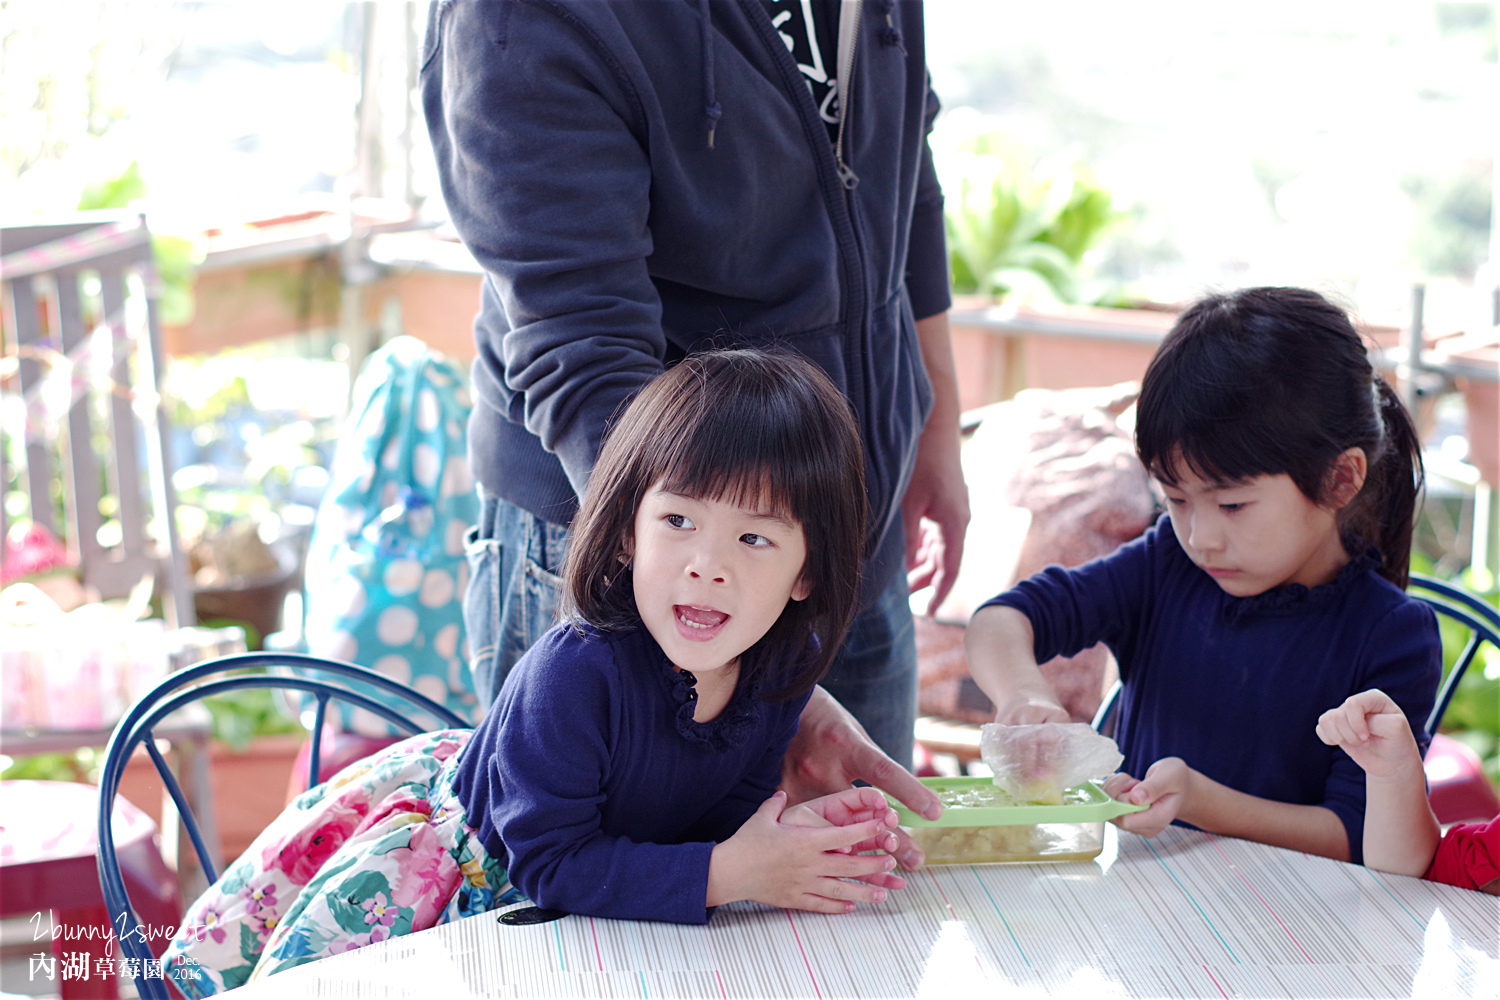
[1092,573,1500,823]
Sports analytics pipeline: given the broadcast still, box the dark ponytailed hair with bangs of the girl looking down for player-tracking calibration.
[1136,288,1422,588]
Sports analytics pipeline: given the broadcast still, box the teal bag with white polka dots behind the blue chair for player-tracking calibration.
[303,336,480,736]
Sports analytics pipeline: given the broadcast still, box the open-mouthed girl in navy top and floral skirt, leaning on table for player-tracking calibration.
[167,351,905,996]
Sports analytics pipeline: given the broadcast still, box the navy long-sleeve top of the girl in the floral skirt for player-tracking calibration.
[453,624,807,924]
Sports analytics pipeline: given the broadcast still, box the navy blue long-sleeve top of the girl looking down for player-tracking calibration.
[989,516,1442,864]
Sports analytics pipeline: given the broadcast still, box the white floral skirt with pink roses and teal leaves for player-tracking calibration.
[162,729,525,997]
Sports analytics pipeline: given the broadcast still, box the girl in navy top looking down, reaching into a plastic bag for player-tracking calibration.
[966,288,1440,862]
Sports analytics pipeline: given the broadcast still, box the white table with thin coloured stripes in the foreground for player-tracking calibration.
[230,826,1500,1000]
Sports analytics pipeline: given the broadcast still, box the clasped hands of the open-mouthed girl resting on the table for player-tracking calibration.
[707,789,905,913]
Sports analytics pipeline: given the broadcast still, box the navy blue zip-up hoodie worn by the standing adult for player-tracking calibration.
[422,0,948,583]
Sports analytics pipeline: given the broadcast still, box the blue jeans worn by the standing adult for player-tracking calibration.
[464,492,917,768]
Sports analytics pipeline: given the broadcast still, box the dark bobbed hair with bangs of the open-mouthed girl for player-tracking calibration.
[563,349,866,700]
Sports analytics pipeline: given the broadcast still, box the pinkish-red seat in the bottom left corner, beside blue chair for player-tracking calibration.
[0,781,183,1000]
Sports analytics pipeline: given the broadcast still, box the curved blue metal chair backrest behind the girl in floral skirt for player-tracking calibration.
[99,652,468,1000]
